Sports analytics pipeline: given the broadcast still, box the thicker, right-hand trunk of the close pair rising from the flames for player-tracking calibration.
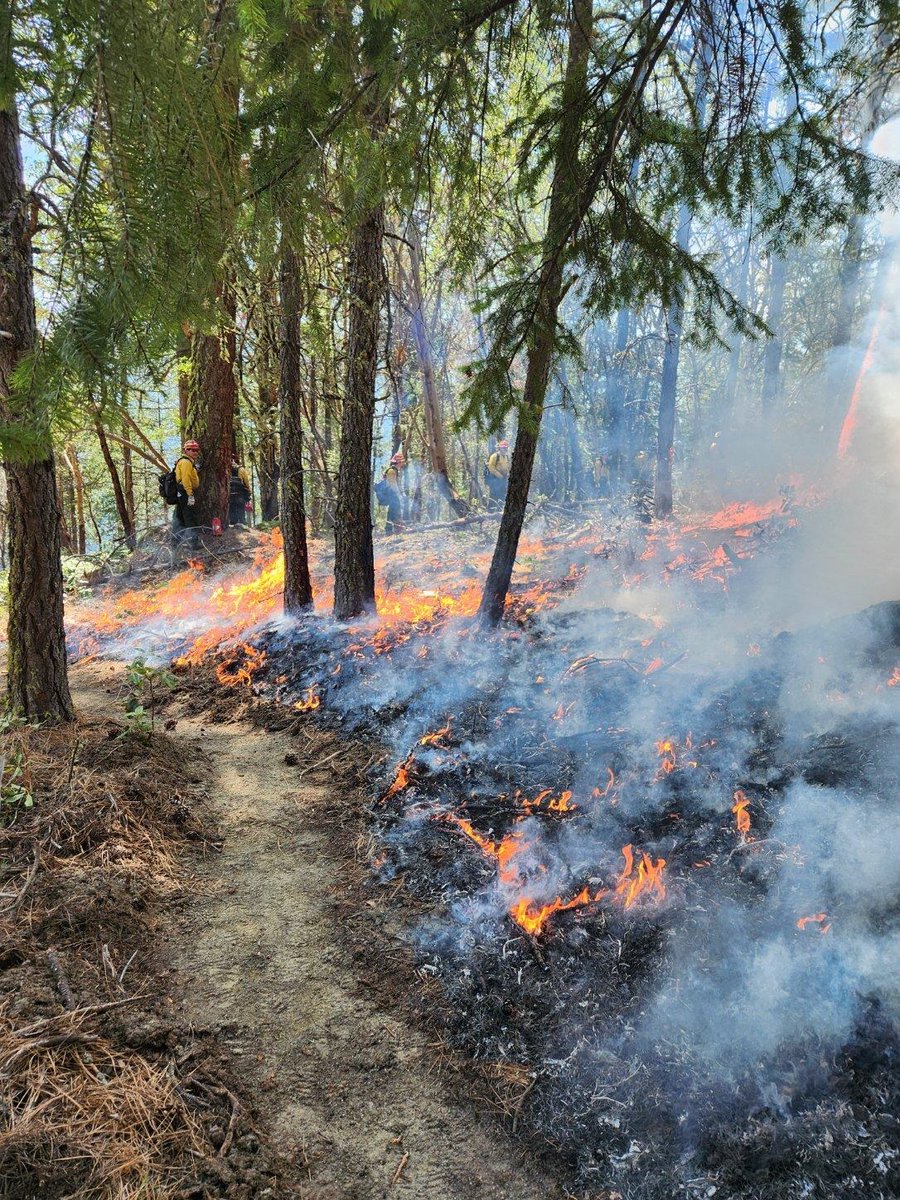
[334,204,384,620]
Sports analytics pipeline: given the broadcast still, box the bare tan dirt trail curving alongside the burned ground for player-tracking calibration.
[74,666,560,1200]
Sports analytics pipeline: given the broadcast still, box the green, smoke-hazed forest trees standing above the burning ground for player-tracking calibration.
[0,0,900,719]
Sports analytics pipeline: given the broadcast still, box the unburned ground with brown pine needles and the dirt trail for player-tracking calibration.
[0,661,563,1200]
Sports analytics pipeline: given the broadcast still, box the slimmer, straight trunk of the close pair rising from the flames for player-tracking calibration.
[278,244,312,612]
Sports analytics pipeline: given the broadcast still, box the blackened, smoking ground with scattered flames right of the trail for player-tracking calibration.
[65,491,900,1198]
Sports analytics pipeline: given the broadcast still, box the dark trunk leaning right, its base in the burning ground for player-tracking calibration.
[479,0,593,625]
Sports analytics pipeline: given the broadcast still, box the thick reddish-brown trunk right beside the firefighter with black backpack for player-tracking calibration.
[187,284,238,528]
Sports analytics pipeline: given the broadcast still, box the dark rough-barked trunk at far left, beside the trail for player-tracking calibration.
[0,46,74,721]
